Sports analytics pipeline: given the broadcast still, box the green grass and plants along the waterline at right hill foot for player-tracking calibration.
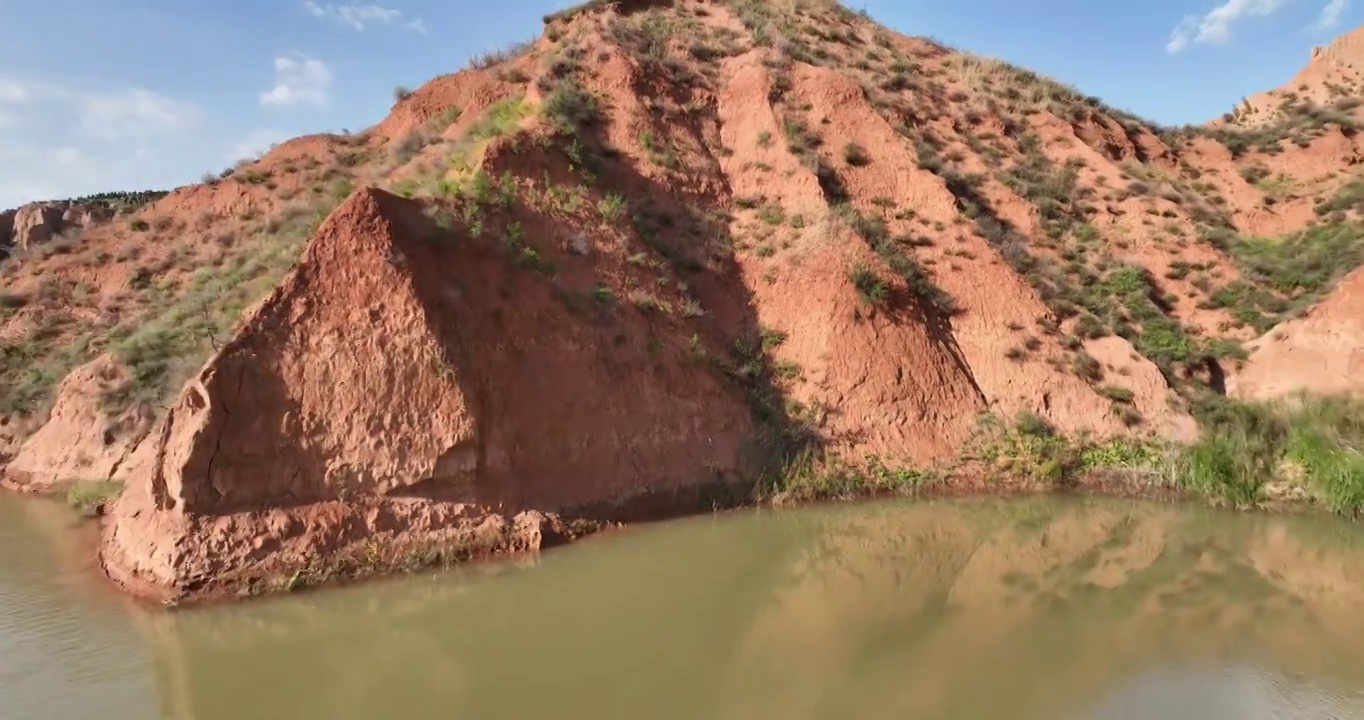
[753,395,1364,517]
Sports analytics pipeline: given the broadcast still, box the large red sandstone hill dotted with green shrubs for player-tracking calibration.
[0,0,1364,596]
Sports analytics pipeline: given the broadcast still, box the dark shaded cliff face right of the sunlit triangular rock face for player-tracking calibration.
[373,120,814,521]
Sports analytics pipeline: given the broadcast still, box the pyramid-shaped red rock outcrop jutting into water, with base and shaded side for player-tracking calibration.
[104,190,750,600]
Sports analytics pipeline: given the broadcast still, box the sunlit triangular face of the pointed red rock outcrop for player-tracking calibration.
[132,191,476,514]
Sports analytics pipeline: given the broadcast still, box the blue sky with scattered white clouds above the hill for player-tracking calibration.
[0,0,1364,207]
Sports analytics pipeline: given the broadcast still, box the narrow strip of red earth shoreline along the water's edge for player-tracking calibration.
[18,470,1330,610]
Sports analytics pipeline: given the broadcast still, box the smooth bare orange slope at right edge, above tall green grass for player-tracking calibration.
[1228,270,1364,400]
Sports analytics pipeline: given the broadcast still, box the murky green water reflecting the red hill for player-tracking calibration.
[0,495,1364,720]
